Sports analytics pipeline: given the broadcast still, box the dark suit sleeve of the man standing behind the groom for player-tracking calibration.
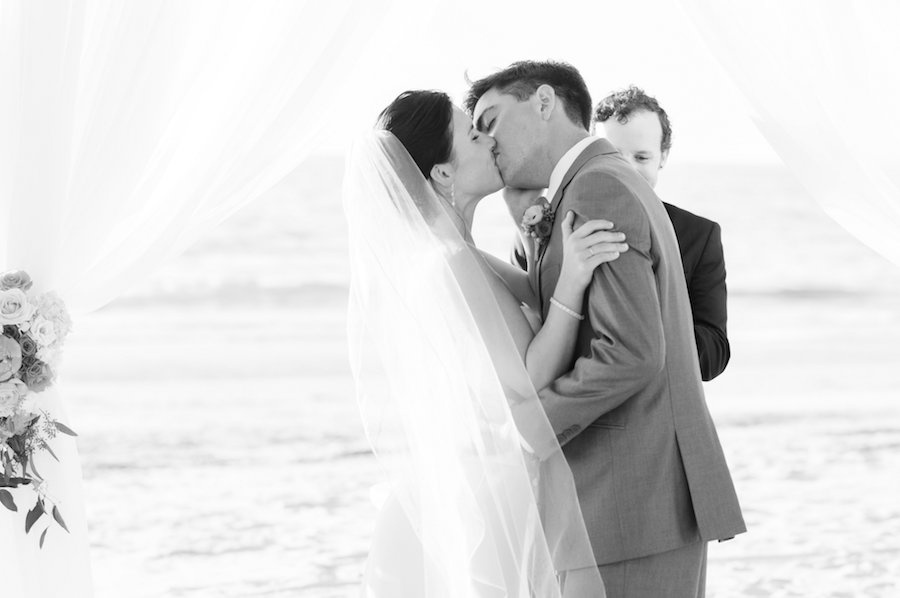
[688,223,731,381]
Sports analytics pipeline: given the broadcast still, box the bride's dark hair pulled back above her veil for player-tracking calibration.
[375,90,453,179]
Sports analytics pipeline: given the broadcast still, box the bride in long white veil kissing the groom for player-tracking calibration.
[344,91,627,598]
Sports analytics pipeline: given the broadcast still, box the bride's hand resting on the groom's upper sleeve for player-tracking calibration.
[557,211,628,292]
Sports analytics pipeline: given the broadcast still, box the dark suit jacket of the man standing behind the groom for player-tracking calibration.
[512,202,731,381]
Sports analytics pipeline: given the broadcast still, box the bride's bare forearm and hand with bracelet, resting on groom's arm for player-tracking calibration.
[525,212,628,390]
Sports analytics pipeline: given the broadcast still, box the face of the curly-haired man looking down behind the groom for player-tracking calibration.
[602,110,668,187]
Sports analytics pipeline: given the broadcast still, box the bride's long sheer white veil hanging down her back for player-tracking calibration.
[344,131,604,598]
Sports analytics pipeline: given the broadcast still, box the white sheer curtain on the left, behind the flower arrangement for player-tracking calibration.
[0,0,412,598]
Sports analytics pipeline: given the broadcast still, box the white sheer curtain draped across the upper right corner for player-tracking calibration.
[682,0,900,265]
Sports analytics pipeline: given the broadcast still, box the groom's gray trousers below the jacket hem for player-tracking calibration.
[560,542,706,598]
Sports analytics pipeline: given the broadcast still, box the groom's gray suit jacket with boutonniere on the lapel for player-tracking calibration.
[529,139,746,569]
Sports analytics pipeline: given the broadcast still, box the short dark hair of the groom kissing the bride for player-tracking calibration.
[465,60,591,130]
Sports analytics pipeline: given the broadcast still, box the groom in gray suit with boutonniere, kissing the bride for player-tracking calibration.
[466,61,746,598]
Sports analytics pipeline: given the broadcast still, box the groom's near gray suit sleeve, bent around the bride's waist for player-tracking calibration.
[539,173,665,445]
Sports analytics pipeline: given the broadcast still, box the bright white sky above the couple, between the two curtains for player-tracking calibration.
[322,0,778,163]
